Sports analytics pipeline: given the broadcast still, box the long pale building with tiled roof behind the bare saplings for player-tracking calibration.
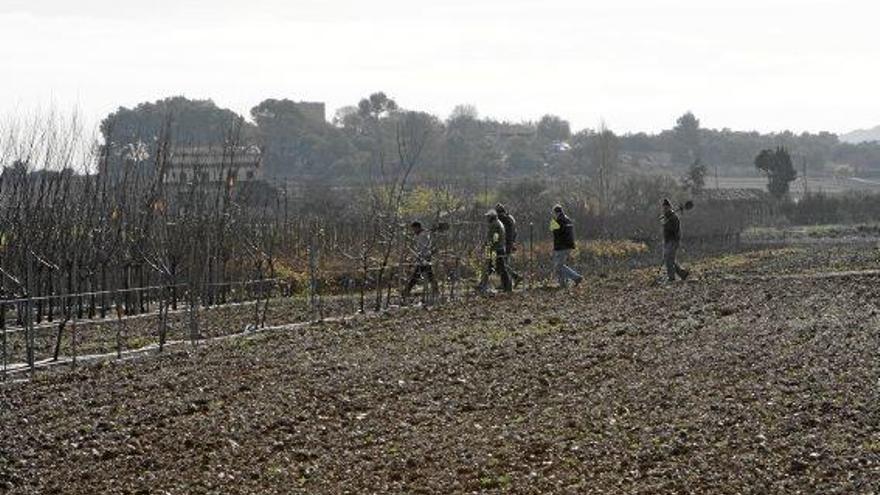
[165,146,263,185]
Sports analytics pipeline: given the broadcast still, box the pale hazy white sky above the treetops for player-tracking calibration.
[0,0,880,132]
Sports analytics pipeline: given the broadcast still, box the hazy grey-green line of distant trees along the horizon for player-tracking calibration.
[100,92,880,189]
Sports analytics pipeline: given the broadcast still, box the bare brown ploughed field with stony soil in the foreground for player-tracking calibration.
[0,245,880,494]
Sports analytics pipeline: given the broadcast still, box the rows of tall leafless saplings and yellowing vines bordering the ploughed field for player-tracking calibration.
[0,120,716,379]
